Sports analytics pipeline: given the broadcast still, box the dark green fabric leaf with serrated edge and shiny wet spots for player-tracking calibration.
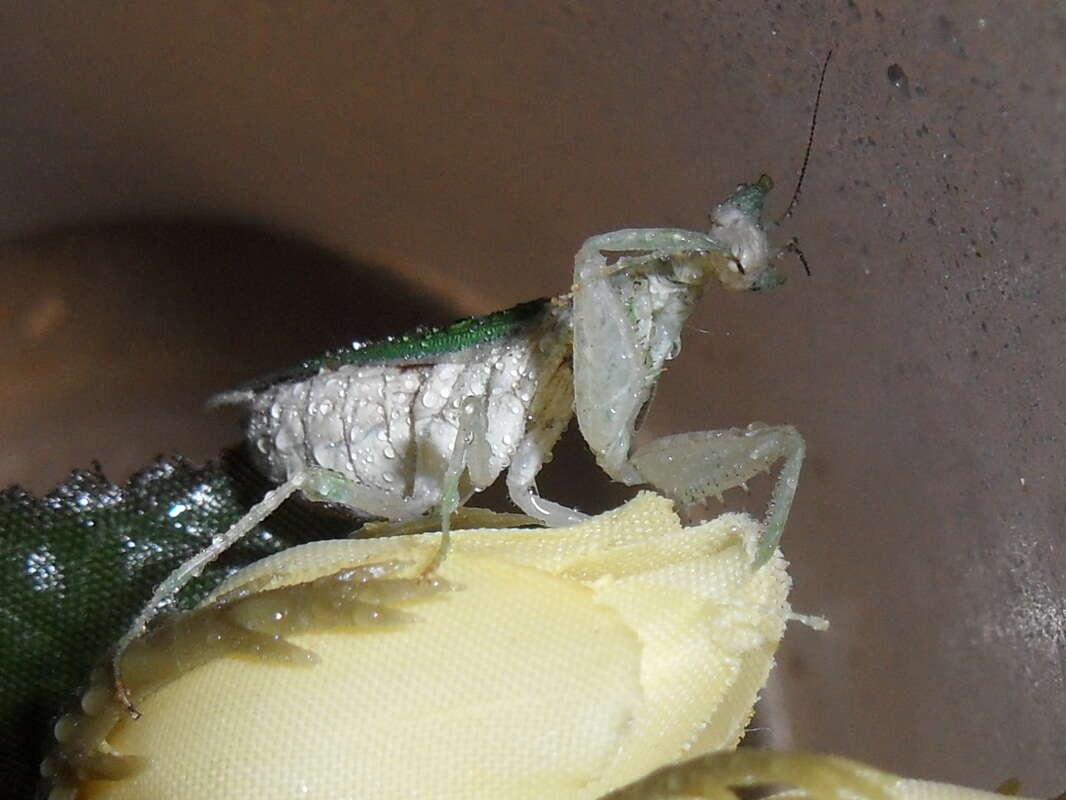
[0,454,353,798]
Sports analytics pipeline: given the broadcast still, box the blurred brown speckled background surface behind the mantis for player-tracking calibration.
[0,0,1066,796]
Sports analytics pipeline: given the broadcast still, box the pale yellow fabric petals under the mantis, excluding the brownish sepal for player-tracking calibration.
[47,493,789,800]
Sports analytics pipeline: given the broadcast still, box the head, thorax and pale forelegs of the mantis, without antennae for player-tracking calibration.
[572,195,804,566]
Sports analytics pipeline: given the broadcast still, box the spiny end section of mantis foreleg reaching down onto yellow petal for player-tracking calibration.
[630,422,805,567]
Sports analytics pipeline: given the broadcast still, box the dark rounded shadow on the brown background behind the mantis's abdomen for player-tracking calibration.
[0,213,632,511]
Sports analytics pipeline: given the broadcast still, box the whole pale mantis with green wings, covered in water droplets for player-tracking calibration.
[112,52,831,716]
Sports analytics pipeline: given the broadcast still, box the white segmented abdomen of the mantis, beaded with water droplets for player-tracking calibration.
[237,320,560,519]
